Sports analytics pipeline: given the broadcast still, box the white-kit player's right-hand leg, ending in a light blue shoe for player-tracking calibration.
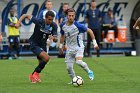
[75,48,94,80]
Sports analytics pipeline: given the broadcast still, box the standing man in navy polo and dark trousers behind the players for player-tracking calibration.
[85,0,101,57]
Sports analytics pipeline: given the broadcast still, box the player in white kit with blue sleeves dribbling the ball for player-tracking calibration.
[59,8,99,80]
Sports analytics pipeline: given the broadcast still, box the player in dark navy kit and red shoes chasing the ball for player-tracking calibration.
[16,11,57,83]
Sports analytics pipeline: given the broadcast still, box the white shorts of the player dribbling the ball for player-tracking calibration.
[65,47,84,62]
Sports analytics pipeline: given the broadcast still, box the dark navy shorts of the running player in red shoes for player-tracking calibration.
[29,41,46,56]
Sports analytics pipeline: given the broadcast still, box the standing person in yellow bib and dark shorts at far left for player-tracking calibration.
[7,8,20,60]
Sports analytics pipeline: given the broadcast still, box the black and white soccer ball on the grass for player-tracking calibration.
[72,76,84,87]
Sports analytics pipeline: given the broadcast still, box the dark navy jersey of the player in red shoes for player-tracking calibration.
[29,17,57,47]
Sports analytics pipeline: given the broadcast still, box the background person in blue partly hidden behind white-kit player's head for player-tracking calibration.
[59,3,69,24]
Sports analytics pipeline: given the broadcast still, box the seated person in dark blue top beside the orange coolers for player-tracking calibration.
[102,8,118,42]
